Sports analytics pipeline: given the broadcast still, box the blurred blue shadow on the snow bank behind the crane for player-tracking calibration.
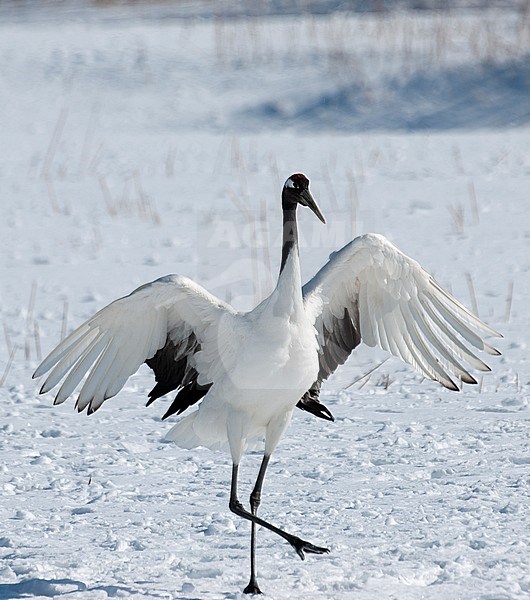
[238,55,530,131]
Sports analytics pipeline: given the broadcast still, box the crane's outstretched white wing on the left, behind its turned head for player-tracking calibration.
[33,275,235,416]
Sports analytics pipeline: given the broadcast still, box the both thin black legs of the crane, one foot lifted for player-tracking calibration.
[229,459,329,593]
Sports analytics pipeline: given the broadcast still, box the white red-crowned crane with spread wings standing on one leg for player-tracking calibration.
[34,173,499,594]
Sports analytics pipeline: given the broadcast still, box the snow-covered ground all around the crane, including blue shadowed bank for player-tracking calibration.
[0,8,530,600]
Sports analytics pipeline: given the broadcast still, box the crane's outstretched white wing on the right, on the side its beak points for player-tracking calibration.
[301,234,500,418]
